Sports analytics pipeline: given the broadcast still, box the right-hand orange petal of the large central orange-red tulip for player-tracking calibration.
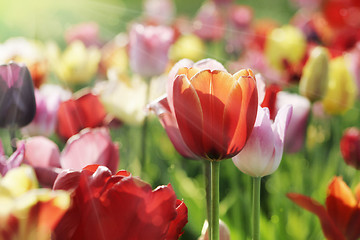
[224,70,258,157]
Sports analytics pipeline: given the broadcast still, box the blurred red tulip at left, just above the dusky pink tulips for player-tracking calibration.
[56,93,106,139]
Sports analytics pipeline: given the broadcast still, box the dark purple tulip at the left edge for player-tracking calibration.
[0,62,36,128]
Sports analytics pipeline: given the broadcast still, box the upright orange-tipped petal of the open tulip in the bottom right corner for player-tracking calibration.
[326,177,356,233]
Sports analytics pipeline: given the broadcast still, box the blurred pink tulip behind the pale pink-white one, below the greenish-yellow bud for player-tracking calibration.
[276,91,311,153]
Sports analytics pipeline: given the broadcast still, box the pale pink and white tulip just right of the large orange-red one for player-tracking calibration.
[233,105,292,177]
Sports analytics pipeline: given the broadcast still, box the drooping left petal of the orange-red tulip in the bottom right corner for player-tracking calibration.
[286,193,346,240]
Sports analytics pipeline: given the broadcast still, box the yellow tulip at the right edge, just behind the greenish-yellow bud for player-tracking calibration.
[322,57,357,114]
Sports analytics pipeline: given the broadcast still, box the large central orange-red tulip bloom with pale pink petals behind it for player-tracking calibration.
[150,59,258,161]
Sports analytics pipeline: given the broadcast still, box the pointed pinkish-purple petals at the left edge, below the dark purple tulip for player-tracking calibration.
[0,141,25,176]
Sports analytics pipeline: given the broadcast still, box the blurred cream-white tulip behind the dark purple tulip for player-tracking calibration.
[0,37,48,88]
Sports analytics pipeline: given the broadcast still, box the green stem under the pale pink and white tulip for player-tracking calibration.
[252,177,261,240]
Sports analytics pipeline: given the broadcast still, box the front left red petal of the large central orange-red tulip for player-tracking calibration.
[173,75,205,156]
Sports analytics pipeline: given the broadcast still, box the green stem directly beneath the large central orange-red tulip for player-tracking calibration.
[209,161,220,240]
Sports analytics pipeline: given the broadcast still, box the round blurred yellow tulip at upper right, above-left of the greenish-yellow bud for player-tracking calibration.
[265,25,306,70]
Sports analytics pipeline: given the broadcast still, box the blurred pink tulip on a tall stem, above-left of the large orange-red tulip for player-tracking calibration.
[129,24,174,77]
